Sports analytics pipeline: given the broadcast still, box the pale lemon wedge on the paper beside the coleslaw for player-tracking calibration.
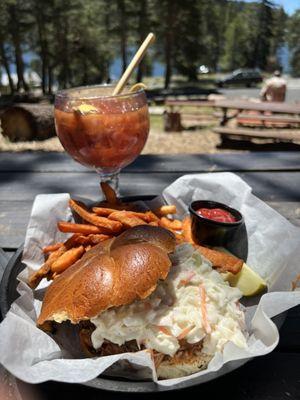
[224,263,267,296]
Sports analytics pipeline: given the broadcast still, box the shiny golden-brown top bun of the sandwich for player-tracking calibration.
[37,225,175,326]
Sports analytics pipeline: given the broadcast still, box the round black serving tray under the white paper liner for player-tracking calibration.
[0,196,286,393]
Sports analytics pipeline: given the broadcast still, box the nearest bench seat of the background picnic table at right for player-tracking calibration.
[213,127,300,142]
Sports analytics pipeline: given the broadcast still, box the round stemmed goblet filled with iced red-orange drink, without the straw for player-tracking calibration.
[54,85,149,193]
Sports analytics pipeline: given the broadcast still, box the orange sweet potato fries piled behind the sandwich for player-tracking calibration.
[29,183,243,288]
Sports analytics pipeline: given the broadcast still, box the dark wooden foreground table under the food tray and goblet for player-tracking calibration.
[0,152,300,400]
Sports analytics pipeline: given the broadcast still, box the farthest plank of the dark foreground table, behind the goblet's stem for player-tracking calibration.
[0,152,300,172]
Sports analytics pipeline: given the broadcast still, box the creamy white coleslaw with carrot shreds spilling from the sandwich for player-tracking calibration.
[91,246,247,356]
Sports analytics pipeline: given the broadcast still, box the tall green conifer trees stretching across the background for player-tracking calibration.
[0,0,292,93]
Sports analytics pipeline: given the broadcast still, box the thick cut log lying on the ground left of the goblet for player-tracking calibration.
[1,103,55,142]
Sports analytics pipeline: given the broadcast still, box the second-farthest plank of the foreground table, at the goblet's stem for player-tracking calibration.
[0,171,300,201]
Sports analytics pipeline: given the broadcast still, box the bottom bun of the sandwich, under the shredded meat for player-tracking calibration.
[157,353,212,379]
